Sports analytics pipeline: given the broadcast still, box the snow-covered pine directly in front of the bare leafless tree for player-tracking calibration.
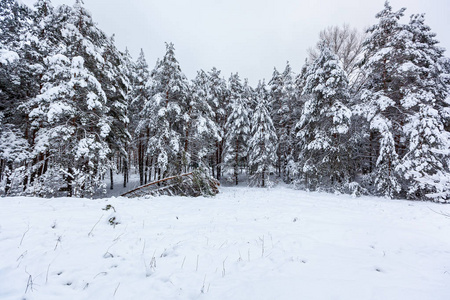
[296,45,352,190]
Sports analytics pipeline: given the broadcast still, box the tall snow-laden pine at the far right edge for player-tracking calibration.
[397,14,450,201]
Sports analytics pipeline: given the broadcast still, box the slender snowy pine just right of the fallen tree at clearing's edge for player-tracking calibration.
[224,73,250,185]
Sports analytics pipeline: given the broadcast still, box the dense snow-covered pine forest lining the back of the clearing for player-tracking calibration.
[0,0,450,202]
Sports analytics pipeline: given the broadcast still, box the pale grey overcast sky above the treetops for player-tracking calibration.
[22,0,450,85]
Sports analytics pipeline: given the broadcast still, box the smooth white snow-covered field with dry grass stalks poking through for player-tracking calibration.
[0,187,450,300]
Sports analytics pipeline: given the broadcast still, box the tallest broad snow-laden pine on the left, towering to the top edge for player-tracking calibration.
[23,1,111,196]
